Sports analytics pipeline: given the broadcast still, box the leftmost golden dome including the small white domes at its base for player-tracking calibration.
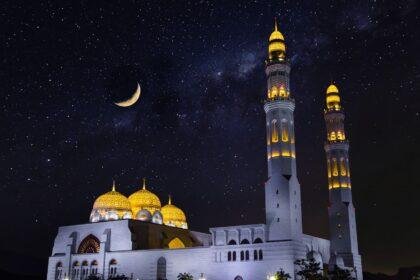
[91,182,132,221]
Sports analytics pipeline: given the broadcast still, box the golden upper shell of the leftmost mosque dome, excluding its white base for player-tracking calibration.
[92,182,131,219]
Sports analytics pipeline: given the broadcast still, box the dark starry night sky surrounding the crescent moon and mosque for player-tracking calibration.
[0,0,420,274]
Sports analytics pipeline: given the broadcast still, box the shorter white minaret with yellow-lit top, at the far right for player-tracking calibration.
[324,84,363,279]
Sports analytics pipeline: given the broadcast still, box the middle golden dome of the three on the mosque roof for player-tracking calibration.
[128,179,161,217]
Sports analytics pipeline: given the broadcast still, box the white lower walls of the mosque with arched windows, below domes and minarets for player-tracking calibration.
[47,220,329,280]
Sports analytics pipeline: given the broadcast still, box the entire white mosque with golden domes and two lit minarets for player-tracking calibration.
[47,20,363,280]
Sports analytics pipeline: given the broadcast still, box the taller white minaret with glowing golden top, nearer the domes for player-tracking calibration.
[264,19,302,241]
